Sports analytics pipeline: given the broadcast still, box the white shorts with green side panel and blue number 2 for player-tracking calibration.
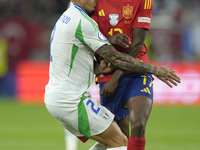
[46,96,114,138]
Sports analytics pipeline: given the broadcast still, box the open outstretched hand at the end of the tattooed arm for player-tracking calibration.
[155,66,181,88]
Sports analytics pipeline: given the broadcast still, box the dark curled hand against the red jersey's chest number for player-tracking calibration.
[107,33,131,48]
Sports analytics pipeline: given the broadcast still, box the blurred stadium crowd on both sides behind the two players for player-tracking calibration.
[0,0,200,95]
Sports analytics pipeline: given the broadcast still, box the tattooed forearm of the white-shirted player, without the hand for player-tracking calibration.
[96,45,158,74]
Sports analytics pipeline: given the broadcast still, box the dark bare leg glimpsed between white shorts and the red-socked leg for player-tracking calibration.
[117,115,129,138]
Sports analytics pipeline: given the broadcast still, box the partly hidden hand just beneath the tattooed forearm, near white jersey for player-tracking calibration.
[99,59,116,73]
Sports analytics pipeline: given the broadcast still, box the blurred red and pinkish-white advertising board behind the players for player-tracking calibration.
[16,61,200,105]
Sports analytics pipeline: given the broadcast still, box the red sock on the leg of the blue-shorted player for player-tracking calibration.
[127,135,146,150]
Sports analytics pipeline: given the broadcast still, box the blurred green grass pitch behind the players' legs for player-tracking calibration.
[0,100,200,150]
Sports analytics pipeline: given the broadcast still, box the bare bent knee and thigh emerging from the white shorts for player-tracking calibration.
[91,121,128,148]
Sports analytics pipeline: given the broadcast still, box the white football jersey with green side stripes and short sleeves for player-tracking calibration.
[45,3,110,107]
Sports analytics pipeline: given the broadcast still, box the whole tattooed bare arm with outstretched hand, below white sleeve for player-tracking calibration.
[96,44,180,87]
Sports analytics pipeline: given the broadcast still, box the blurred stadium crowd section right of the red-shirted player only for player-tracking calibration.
[150,0,200,61]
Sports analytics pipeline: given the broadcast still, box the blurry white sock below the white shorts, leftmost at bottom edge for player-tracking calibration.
[65,129,78,150]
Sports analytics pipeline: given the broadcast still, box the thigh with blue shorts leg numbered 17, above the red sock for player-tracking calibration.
[124,73,153,124]
